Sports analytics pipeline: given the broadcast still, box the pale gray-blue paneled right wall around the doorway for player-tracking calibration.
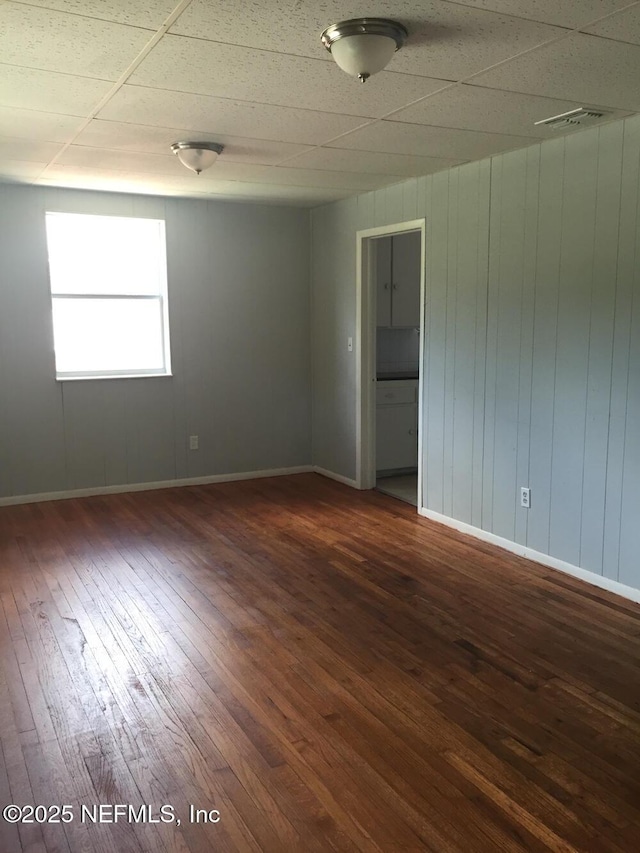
[312,117,640,588]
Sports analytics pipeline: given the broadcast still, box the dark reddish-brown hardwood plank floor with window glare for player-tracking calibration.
[0,474,640,853]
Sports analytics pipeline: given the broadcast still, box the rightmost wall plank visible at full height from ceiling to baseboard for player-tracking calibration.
[580,122,624,574]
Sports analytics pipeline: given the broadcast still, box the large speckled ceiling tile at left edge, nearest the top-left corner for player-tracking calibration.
[0,3,150,80]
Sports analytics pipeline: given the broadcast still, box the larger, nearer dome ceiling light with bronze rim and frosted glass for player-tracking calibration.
[320,18,409,83]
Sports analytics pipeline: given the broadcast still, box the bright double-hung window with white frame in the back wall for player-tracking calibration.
[46,213,171,379]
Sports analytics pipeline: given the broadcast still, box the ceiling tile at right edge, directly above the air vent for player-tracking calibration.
[474,33,640,112]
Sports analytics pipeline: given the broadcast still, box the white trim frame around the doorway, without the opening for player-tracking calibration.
[356,218,427,510]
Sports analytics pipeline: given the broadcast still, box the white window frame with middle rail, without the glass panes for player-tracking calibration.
[45,209,173,382]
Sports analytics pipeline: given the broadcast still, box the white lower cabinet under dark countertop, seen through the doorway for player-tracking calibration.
[376,379,418,471]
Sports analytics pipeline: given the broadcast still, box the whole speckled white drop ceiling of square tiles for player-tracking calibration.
[0,0,640,207]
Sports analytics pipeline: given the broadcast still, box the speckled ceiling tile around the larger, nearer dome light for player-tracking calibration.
[171,0,558,80]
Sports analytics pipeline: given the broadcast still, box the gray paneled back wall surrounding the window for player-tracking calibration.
[0,184,311,497]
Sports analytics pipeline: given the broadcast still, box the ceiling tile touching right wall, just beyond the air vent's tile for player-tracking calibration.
[331,121,536,161]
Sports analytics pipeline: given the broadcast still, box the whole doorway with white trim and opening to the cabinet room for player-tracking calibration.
[356,219,426,507]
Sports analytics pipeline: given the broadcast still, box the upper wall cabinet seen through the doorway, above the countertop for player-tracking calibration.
[375,231,420,328]
